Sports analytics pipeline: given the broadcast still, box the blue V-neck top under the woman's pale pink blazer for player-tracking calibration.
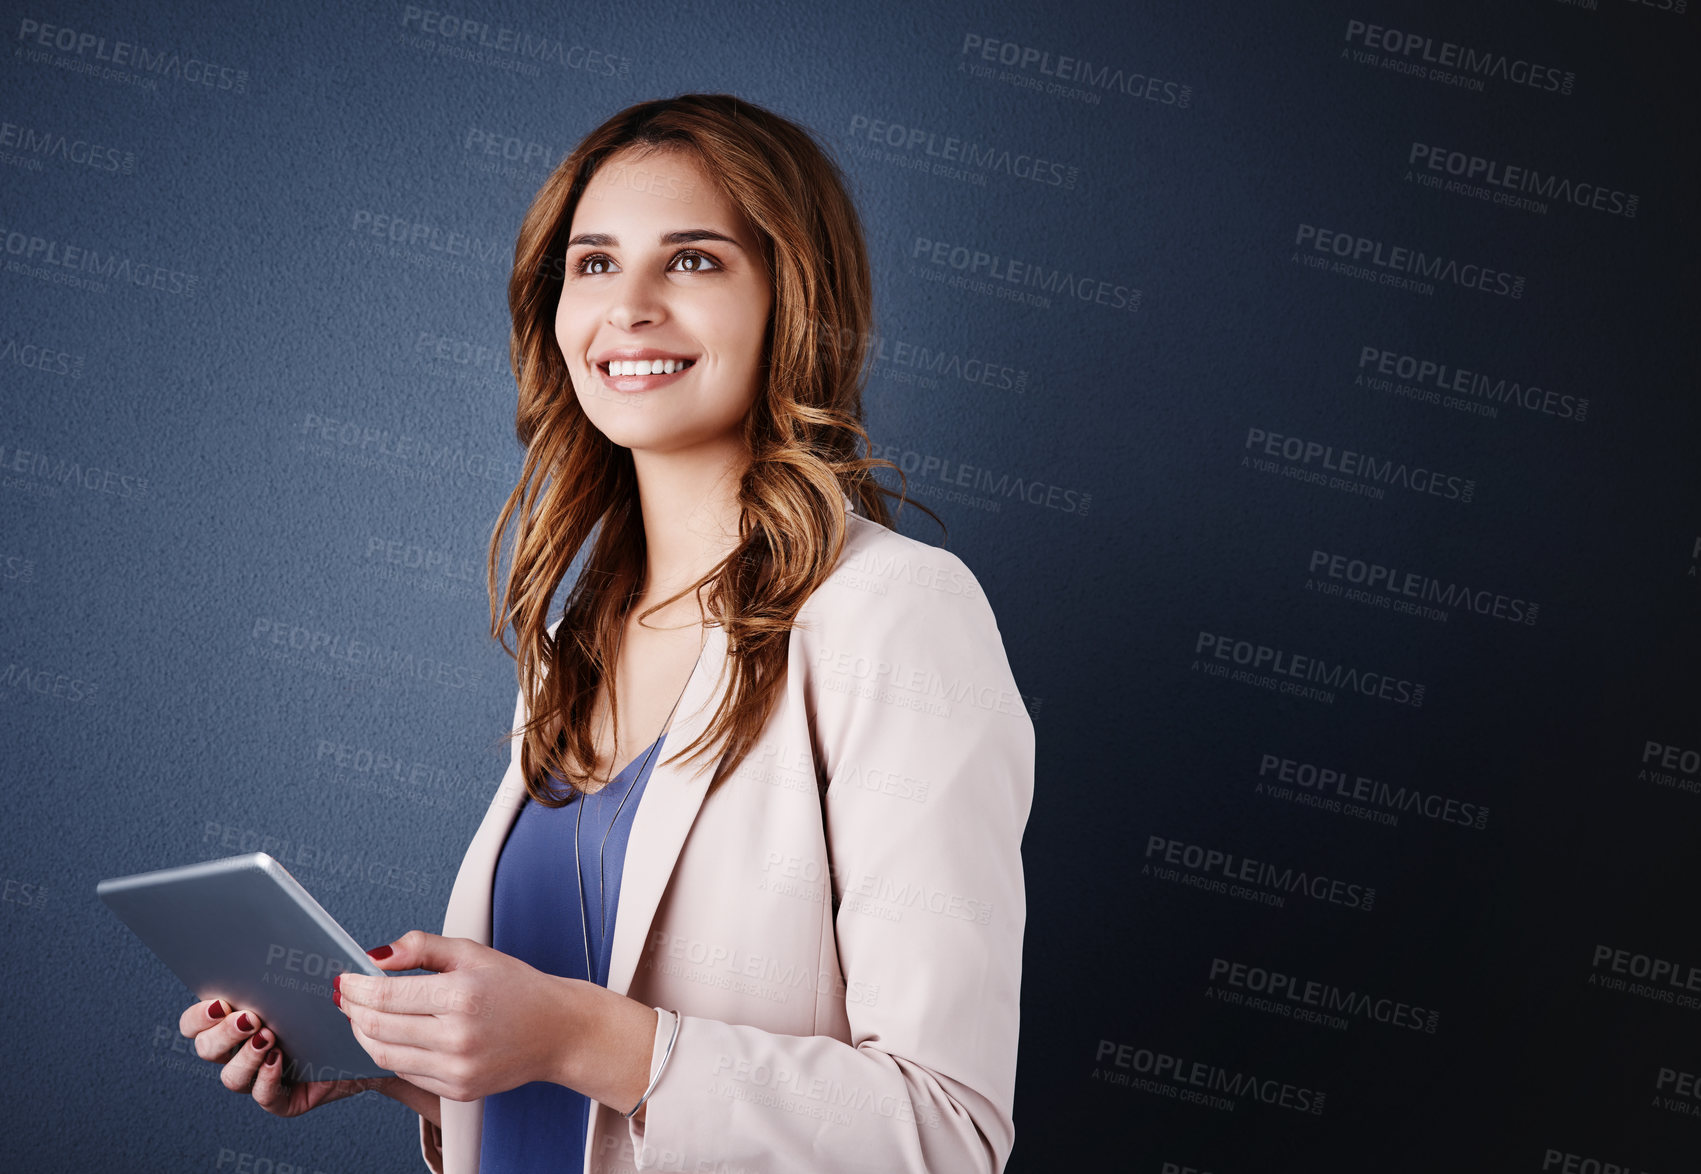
[478,732,667,1174]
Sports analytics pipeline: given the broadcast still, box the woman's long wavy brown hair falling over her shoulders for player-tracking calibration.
[488,94,939,806]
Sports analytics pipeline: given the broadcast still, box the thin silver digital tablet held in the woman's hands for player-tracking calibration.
[95,852,395,1082]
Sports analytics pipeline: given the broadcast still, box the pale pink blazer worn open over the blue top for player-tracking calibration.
[420,499,1034,1174]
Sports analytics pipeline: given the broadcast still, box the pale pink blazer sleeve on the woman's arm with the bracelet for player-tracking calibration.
[628,548,1034,1174]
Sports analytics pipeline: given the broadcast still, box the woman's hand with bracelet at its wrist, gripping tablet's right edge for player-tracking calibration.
[335,929,585,1101]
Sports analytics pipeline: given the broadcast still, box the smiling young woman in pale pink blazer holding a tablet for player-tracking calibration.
[182,95,1034,1174]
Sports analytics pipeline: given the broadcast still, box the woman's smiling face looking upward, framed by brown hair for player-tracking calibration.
[555,148,774,453]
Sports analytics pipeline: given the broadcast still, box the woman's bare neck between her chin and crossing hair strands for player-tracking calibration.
[633,439,750,624]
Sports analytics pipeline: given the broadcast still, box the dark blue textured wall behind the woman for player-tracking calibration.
[0,0,1701,1174]
